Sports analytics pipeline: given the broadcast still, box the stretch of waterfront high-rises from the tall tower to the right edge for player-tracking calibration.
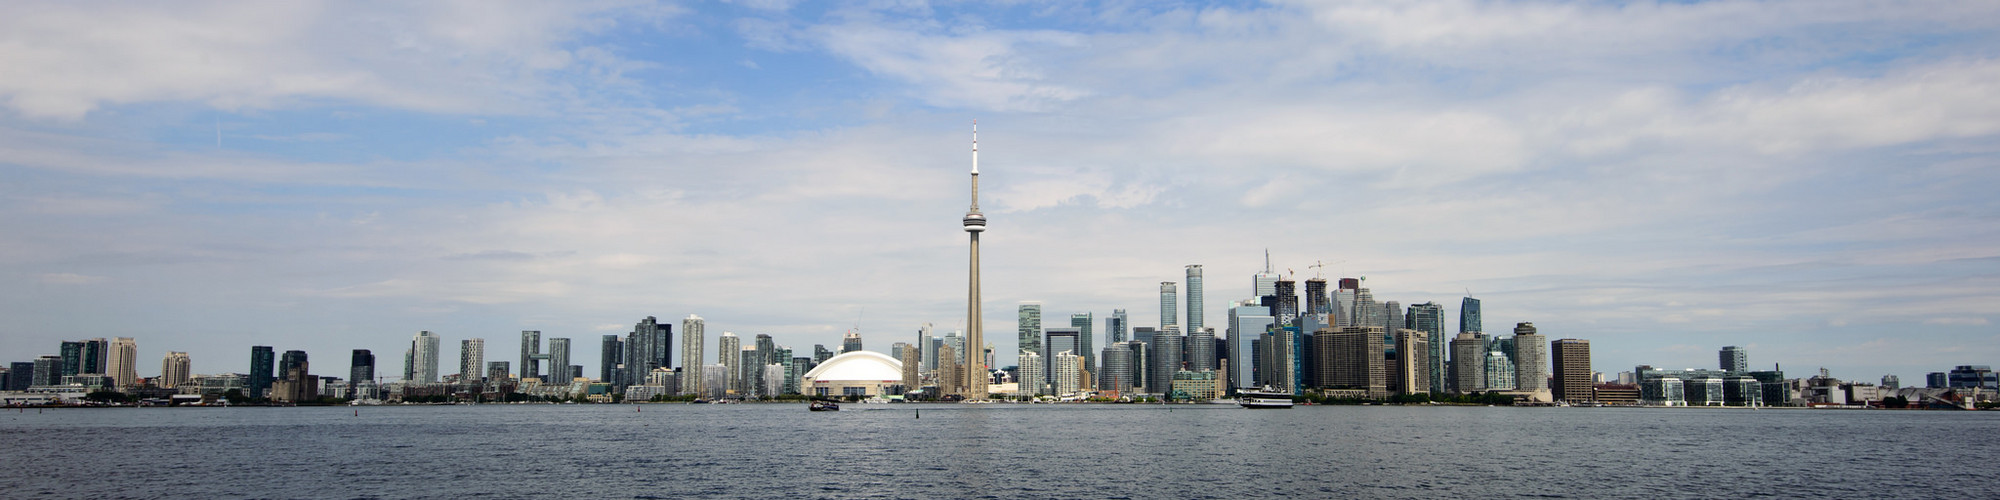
[984,254,1996,408]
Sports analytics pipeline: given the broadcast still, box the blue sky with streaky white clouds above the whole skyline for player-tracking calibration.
[0,0,2000,384]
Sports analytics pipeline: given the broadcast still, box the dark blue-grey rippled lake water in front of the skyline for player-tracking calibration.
[0,404,2000,498]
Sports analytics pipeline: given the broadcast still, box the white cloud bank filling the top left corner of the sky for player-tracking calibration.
[0,2,672,120]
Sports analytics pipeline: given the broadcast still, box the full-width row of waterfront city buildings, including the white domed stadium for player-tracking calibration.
[0,272,2000,408]
